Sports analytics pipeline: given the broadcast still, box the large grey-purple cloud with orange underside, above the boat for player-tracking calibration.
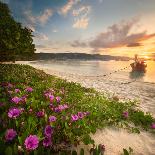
[89,19,155,49]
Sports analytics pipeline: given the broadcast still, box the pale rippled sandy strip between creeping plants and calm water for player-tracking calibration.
[25,62,155,117]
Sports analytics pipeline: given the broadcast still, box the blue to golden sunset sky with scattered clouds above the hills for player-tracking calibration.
[1,0,155,57]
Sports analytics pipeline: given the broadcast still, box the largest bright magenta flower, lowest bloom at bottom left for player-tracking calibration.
[24,135,39,150]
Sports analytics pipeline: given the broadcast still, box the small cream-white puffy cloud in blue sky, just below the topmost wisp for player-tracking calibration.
[72,6,91,29]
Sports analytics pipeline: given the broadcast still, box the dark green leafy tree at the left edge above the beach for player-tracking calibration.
[0,2,35,61]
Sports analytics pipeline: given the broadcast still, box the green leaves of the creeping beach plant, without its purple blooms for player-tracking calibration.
[0,64,154,155]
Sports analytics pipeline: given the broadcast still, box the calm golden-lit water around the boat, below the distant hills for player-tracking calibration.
[31,60,155,83]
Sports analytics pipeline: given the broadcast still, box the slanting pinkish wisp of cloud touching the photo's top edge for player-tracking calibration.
[60,0,80,15]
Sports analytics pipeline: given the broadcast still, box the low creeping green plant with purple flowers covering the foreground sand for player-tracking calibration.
[0,64,155,155]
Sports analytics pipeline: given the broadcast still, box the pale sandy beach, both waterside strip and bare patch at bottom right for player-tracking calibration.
[15,62,155,155]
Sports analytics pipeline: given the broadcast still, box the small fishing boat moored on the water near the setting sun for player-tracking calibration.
[130,55,147,72]
